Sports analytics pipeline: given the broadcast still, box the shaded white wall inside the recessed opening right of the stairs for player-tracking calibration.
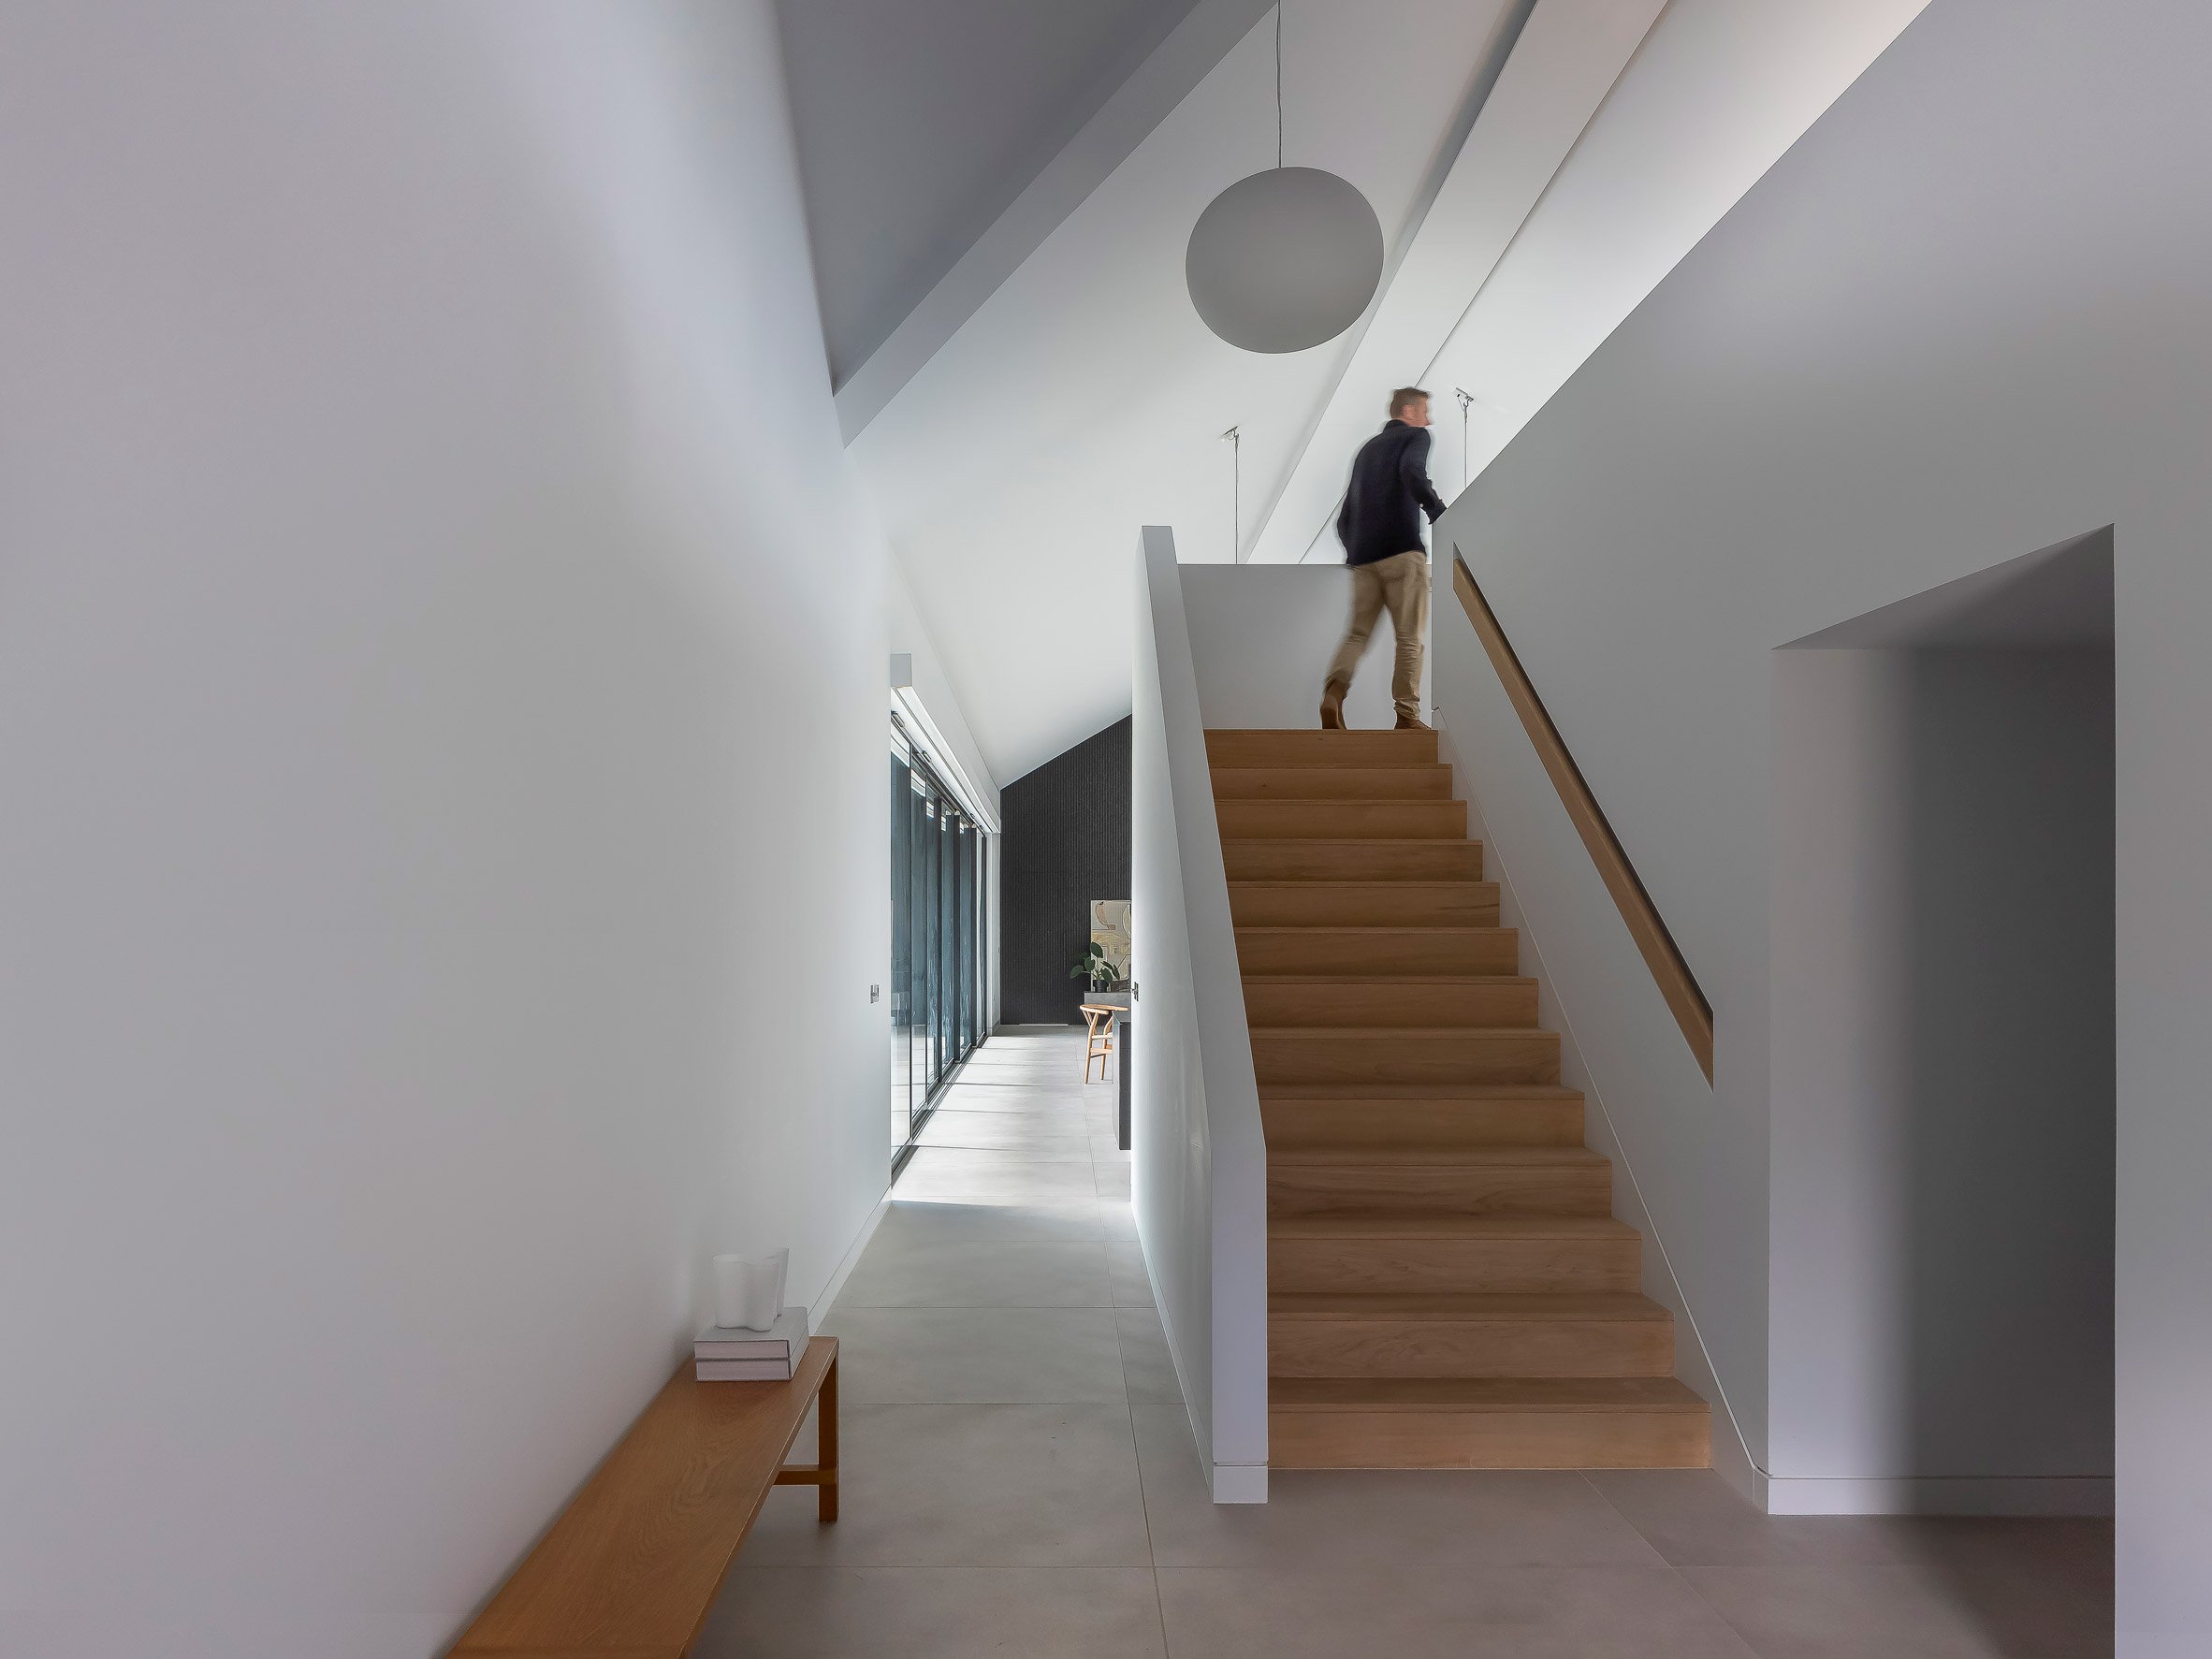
[1772,646,2113,1513]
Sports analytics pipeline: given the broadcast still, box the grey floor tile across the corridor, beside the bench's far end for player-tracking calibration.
[822,1307,1128,1404]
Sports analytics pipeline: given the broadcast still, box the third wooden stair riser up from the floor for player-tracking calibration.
[1268,1234,1641,1294]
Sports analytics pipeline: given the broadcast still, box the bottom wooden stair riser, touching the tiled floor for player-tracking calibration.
[1268,1411,1712,1469]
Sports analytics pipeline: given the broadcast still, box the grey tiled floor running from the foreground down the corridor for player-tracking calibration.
[697,1028,2113,1659]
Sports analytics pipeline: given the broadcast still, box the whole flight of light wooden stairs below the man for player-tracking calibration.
[1205,730,1710,1469]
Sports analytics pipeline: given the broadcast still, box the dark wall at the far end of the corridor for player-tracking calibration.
[997,719,1130,1026]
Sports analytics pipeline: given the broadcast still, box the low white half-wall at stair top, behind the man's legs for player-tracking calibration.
[1184,564,1448,730]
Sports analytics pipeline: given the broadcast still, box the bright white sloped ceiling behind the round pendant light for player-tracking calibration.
[794,0,1925,783]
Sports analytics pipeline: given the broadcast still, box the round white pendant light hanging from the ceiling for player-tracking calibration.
[1184,168,1383,352]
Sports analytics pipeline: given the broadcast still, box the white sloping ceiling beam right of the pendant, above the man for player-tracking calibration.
[1245,0,1666,564]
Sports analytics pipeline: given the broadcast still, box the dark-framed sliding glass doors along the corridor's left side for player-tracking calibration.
[892,719,986,1157]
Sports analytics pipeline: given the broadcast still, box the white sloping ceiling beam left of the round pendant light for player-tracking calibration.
[837,0,1272,444]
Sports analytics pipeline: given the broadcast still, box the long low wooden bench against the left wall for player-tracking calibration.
[449,1336,837,1659]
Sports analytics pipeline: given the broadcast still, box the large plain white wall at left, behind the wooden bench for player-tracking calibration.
[0,0,977,1659]
